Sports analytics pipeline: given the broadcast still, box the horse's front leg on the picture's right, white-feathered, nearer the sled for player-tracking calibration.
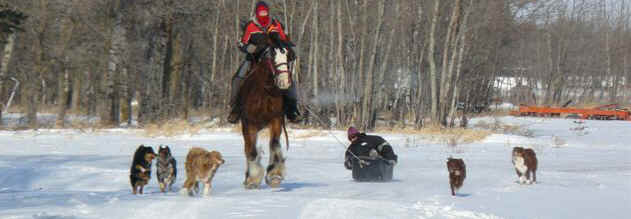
[265,118,285,187]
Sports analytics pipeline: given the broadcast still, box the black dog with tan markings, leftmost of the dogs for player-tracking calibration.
[129,145,156,195]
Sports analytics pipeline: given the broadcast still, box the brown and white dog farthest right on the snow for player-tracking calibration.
[513,147,537,184]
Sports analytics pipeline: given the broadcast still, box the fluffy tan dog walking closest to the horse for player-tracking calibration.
[181,147,225,196]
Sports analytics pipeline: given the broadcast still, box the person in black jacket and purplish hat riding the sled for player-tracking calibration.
[344,126,397,170]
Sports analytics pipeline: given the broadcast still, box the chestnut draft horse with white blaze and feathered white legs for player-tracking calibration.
[238,37,291,189]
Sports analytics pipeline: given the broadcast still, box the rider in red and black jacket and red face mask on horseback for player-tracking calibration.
[228,1,302,123]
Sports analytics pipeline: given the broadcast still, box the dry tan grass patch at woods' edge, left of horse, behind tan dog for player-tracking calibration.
[144,119,202,137]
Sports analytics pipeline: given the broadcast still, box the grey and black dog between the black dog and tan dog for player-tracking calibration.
[156,145,177,192]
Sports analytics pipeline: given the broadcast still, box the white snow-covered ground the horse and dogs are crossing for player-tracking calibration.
[0,117,631,219]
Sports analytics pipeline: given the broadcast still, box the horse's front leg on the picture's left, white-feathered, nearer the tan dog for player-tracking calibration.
[241,122,264,189]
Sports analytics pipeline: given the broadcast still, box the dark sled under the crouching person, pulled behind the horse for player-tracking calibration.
[353,156,394,182]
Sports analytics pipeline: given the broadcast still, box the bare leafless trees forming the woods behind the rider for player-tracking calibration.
[0,0,631,129]
